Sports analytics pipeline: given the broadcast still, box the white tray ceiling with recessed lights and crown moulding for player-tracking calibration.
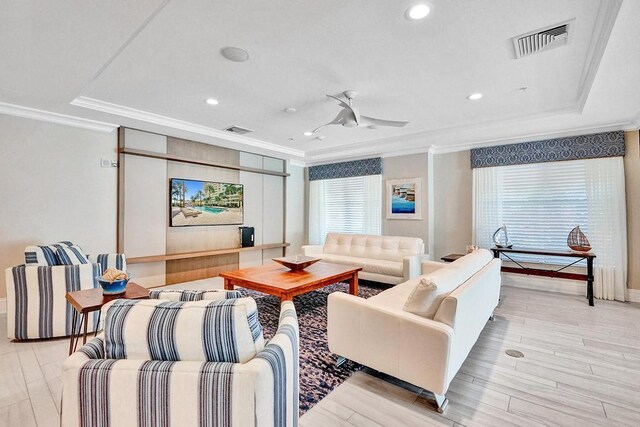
[0,0,640,162]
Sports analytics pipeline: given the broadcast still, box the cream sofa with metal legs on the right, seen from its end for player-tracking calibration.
[327,249,501,412]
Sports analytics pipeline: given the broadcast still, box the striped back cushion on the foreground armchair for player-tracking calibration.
[103,298,264,363]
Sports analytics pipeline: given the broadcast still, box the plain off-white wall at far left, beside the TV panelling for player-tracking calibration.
[0,115,117,298]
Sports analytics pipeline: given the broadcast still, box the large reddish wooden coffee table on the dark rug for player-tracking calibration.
[220,262,362,301]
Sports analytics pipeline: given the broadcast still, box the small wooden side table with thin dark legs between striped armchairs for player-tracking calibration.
[65,282,149,355]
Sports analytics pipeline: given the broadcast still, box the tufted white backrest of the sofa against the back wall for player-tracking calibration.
[323,233,424,262]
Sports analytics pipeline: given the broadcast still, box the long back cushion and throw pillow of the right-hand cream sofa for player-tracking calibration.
[403,249,493,319]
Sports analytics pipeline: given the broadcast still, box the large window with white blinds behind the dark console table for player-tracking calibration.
[474,160,590,265]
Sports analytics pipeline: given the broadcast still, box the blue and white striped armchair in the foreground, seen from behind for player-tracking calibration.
[61,292,299,427]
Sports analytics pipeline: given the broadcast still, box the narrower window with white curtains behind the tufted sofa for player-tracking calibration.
[309,175,382,244]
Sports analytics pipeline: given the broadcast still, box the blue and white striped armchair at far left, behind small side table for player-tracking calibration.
[5,247,127,340]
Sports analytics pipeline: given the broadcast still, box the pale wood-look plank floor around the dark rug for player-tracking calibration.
[0,287,640,427]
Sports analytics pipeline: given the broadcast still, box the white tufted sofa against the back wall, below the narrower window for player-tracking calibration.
[302,233,426,285]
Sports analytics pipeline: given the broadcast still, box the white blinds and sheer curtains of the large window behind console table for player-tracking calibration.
[473,157,627,301]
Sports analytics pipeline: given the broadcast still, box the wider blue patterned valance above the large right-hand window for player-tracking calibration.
[471,131,624,168]
